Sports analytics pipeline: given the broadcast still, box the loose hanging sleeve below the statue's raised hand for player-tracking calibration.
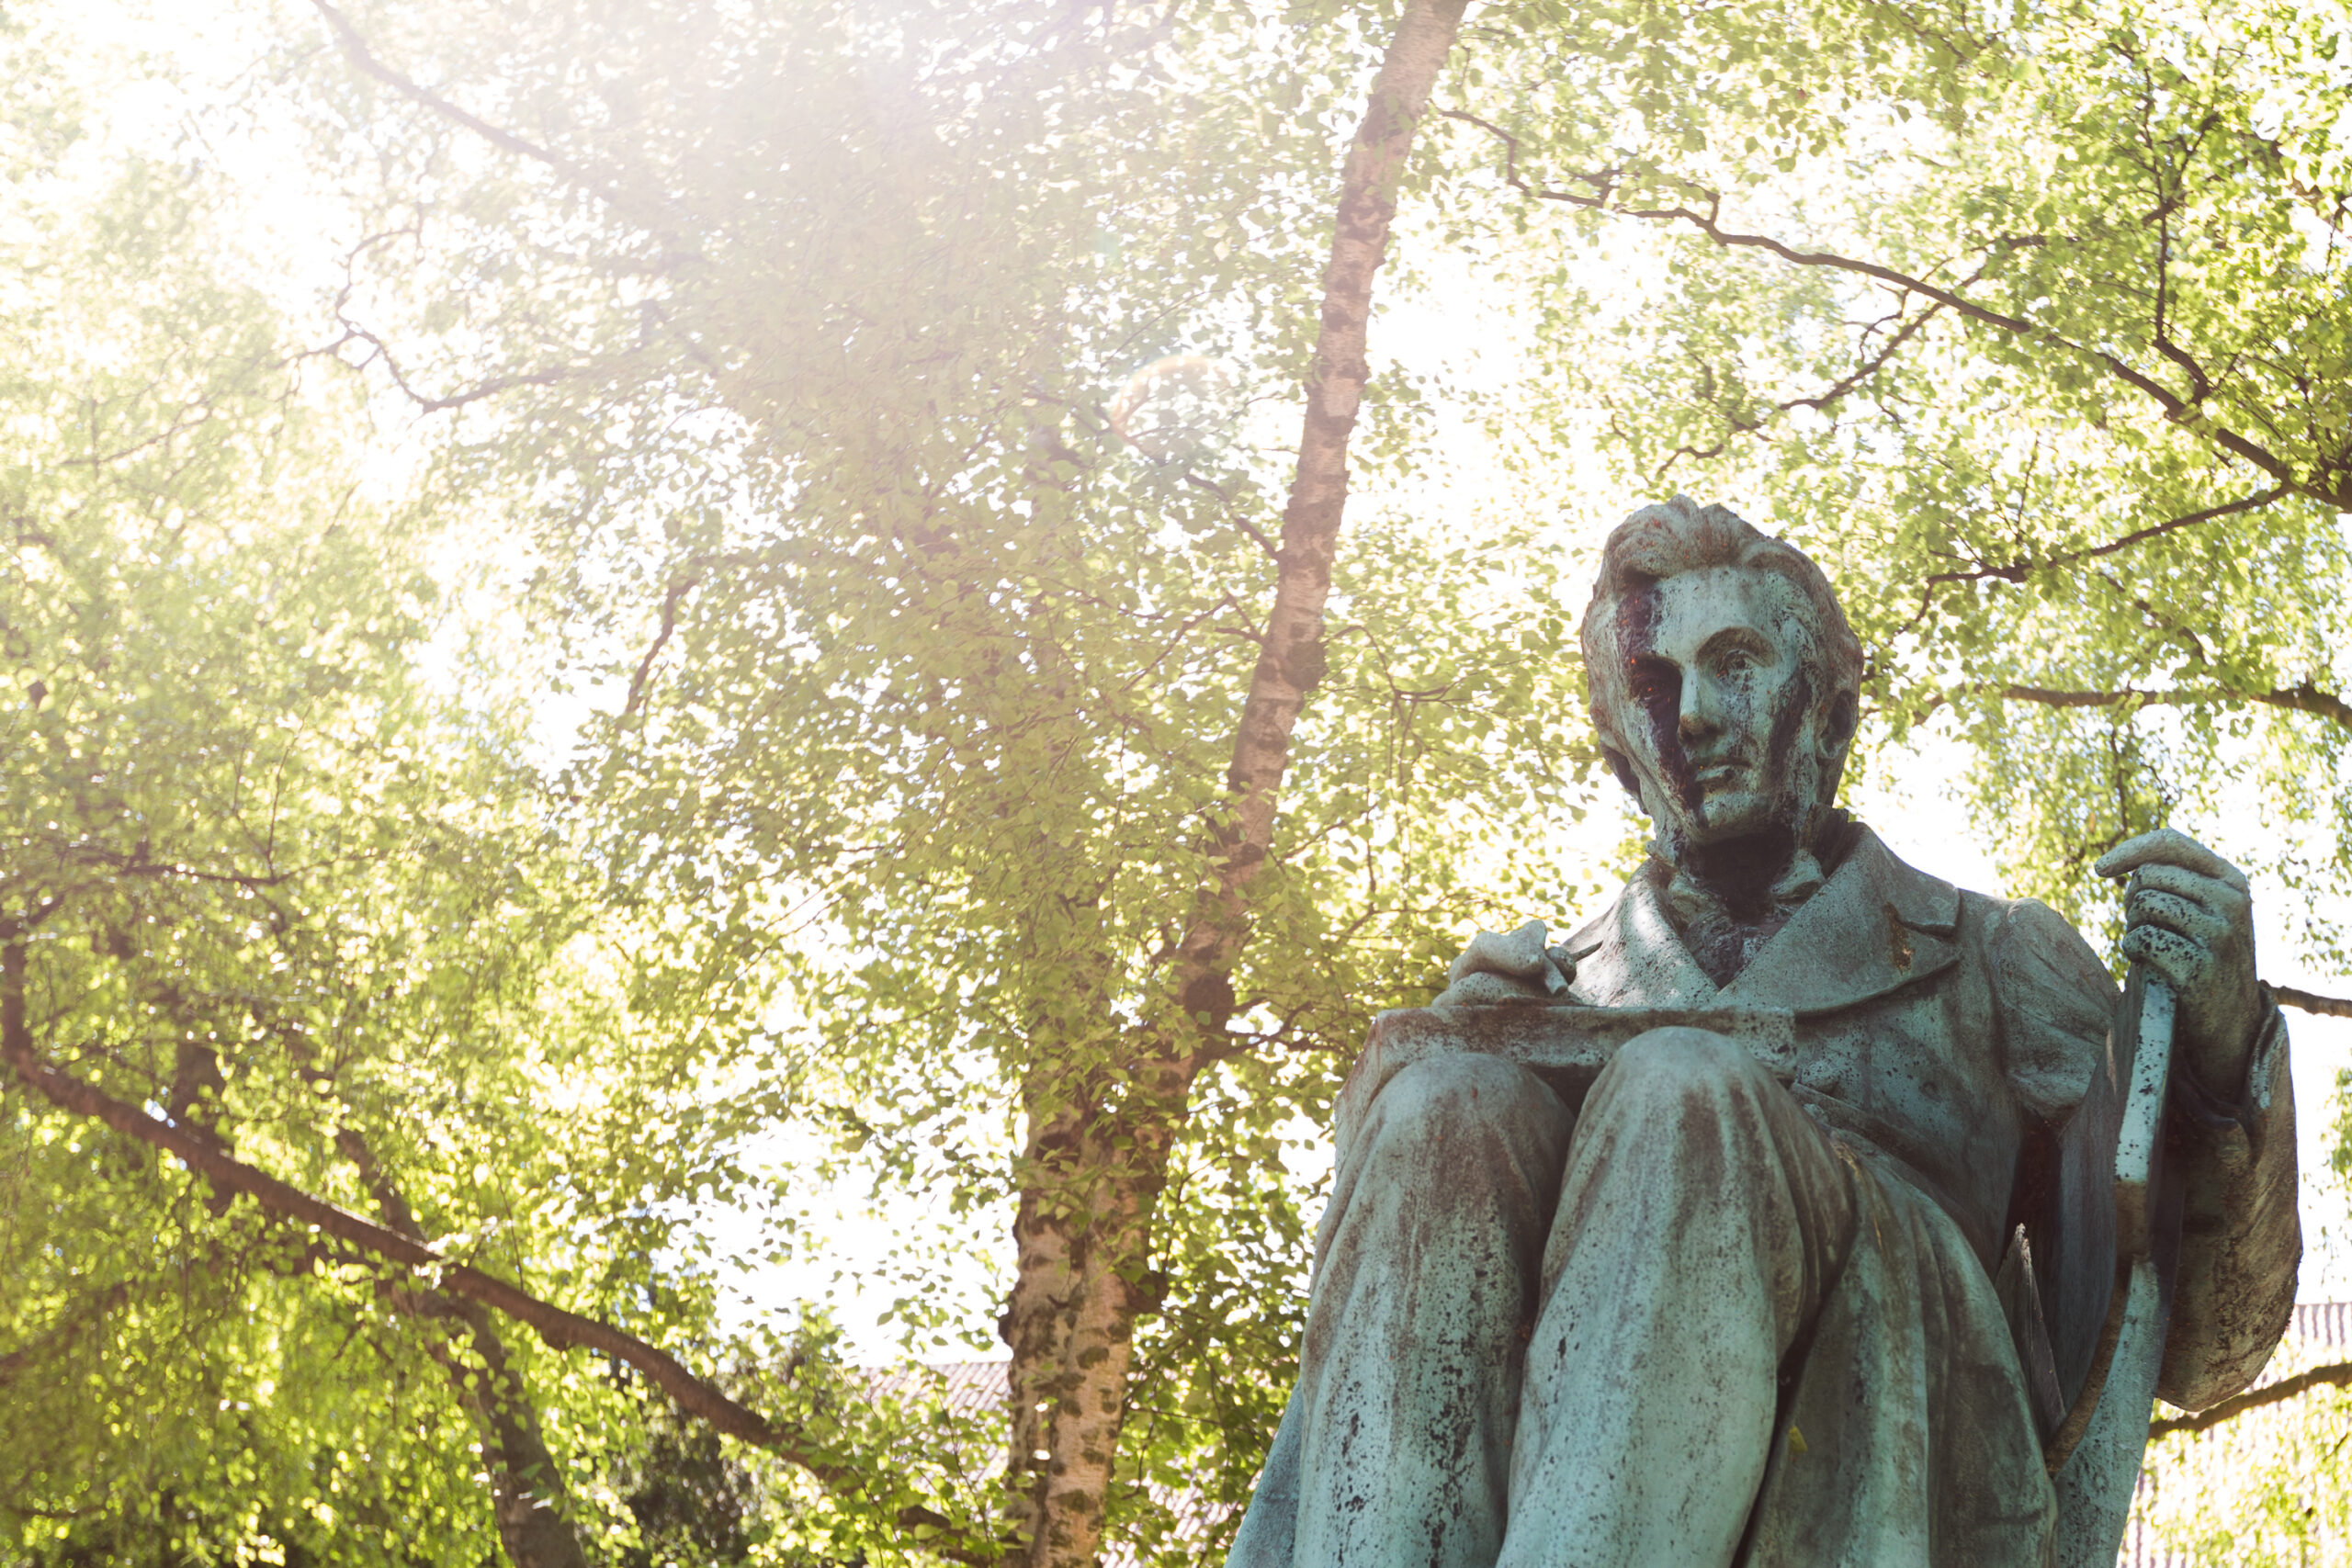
[2157,987,2302,1411]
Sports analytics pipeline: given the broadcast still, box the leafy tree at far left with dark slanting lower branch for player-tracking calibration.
[0,17,888,1565]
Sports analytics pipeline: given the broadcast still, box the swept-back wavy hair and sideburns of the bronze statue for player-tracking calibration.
[1578,493,1863,795]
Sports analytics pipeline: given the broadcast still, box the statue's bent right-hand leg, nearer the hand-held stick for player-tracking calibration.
[1500,1027,1856,1568]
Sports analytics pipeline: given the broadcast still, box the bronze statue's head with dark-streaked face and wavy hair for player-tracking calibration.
[1583,496,1863,863]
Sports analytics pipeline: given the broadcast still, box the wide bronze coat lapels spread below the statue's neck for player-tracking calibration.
[1564,828,1959,1013]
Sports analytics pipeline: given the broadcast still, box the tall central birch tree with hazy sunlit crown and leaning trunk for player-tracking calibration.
[275,7,1574,1561]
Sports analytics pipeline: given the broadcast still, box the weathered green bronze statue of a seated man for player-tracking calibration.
[1227,496,2302,1568]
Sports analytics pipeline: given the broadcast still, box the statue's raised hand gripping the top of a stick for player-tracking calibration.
[2093,828,2263,1105]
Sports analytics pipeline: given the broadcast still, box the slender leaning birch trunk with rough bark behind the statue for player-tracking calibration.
[1004,0,1465,1568]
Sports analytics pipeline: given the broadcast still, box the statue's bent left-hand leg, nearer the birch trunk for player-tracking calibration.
[1279,1055,1574,1568]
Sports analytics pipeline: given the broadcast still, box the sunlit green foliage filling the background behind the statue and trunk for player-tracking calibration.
[0,0,2352,1561]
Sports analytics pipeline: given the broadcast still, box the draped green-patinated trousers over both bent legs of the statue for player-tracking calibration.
[1227,1030,2053,1568]
